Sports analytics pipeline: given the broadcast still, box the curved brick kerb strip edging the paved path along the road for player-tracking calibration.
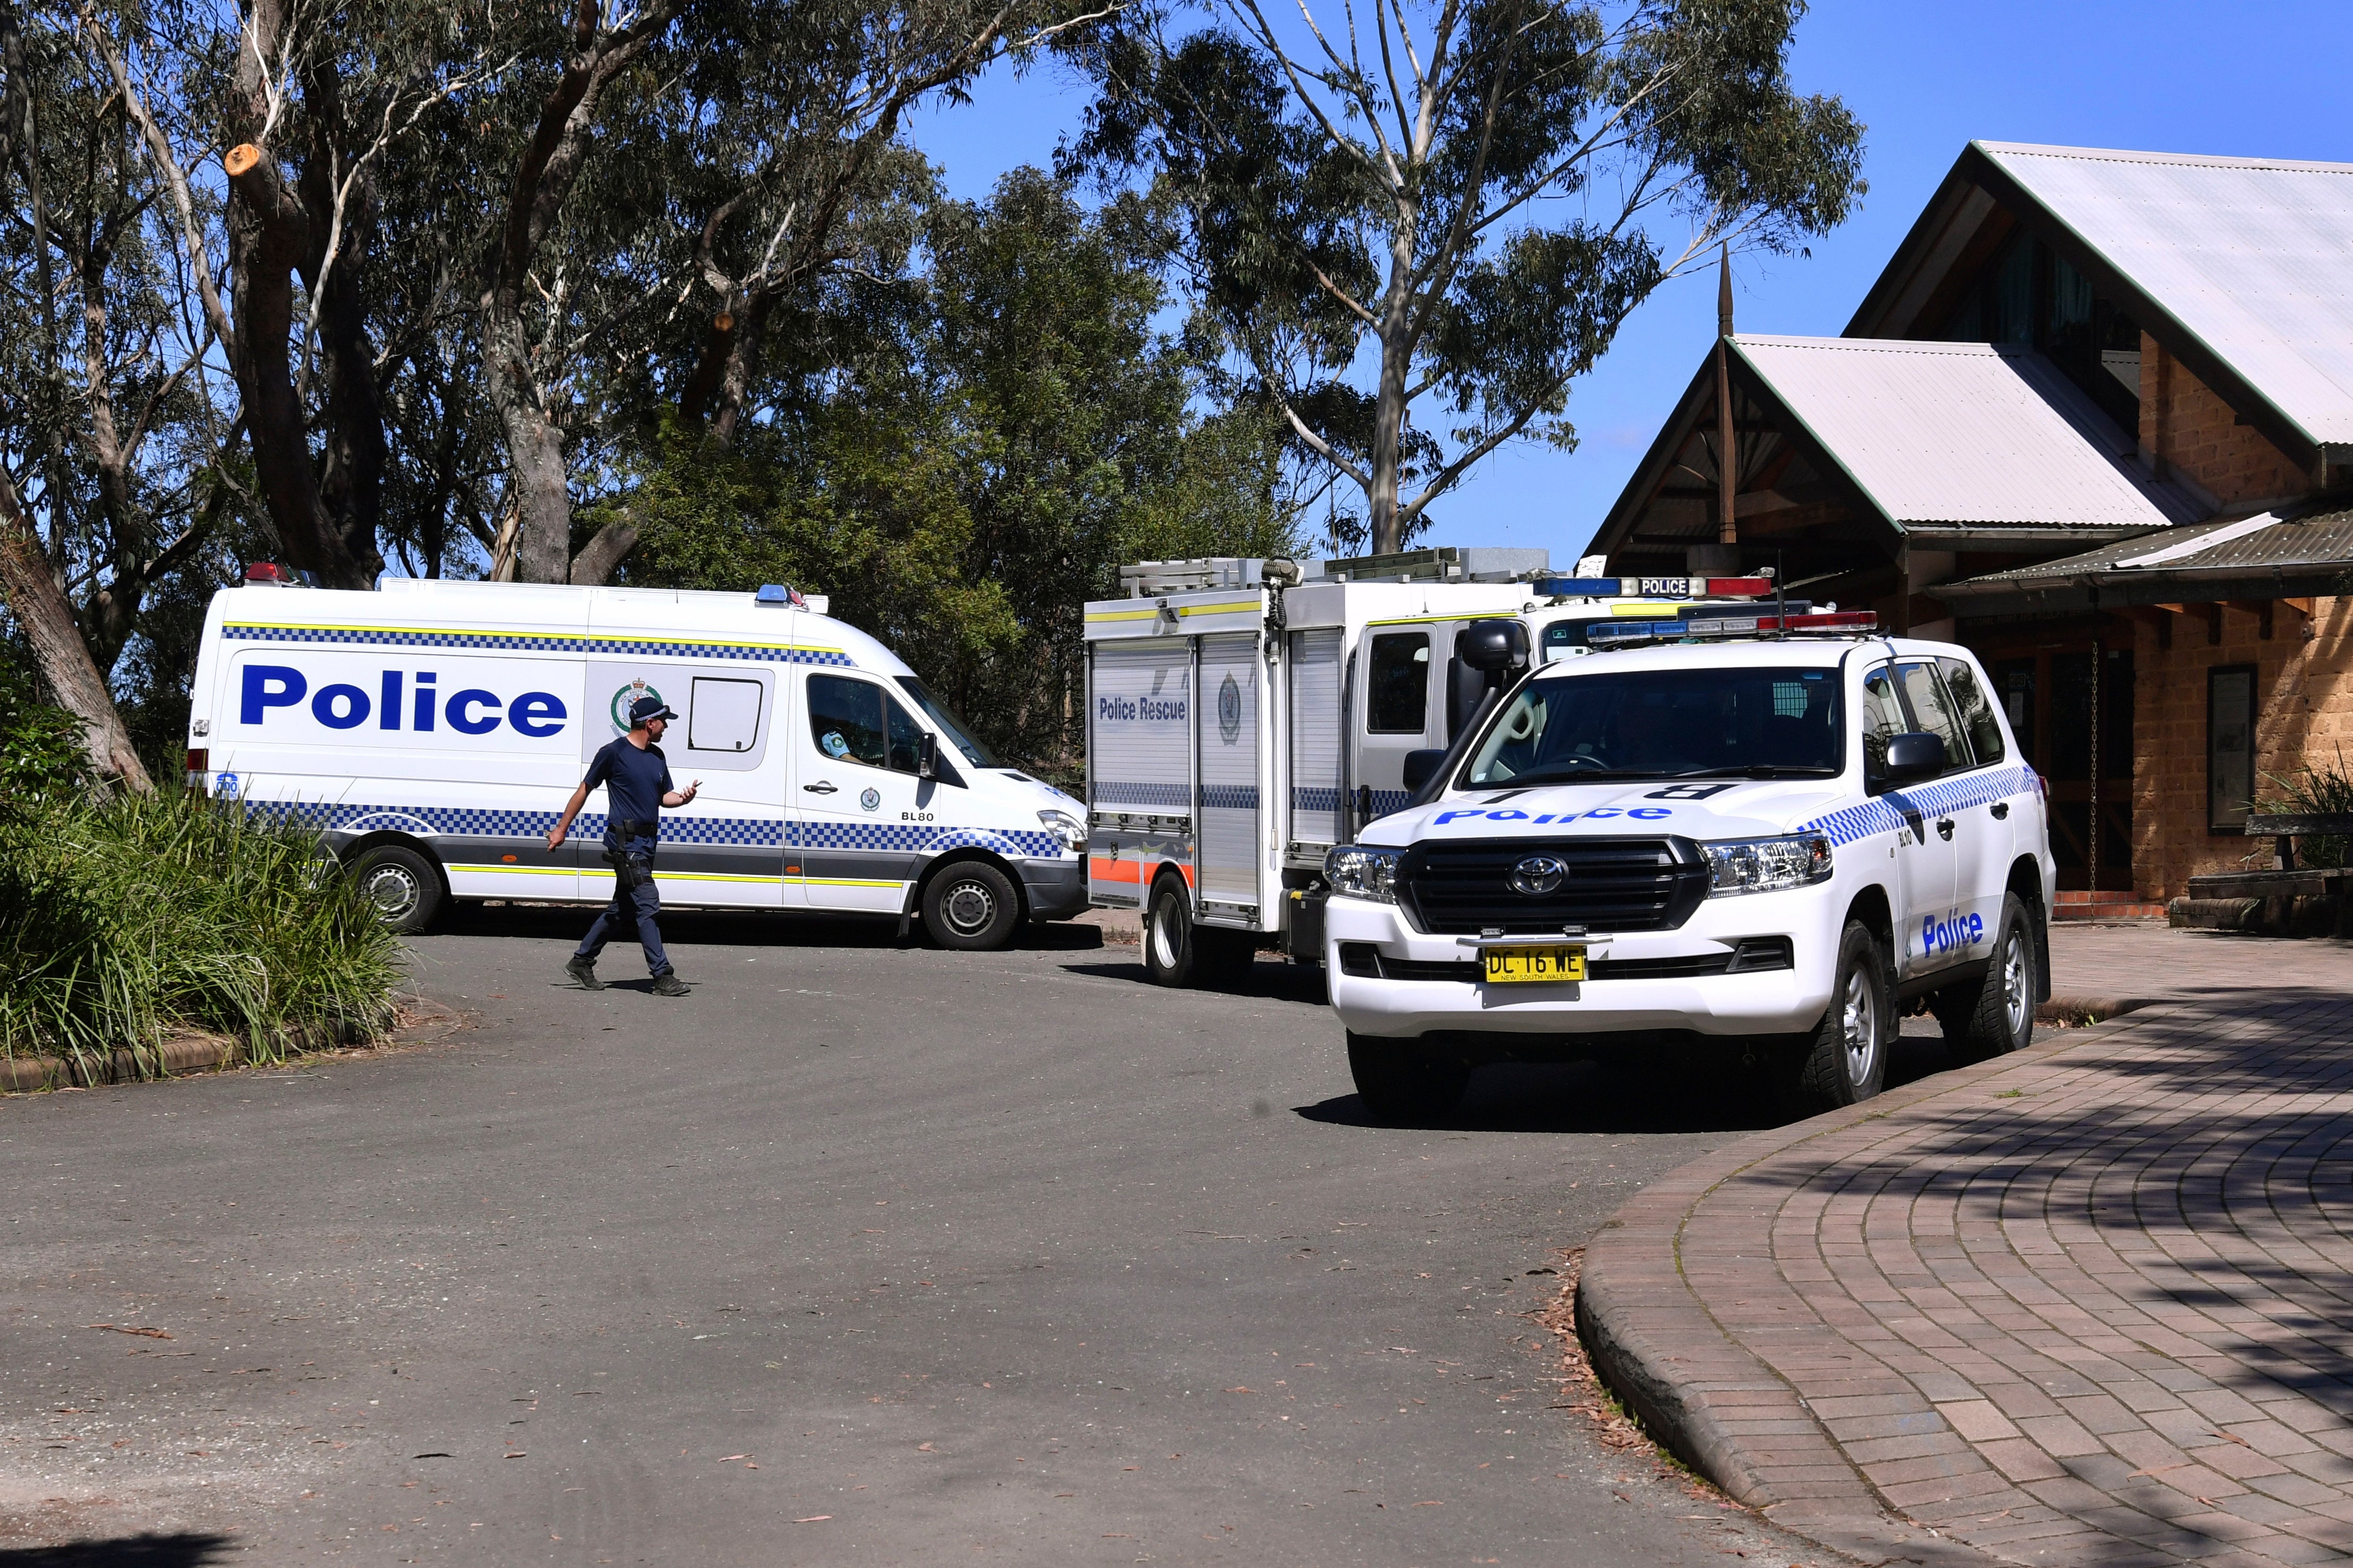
[1576,999,2179,1568]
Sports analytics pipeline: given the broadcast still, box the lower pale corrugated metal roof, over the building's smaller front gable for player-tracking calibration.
[1732,336,2200,534]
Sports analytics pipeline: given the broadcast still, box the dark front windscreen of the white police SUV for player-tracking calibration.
[1463,665,1845,790]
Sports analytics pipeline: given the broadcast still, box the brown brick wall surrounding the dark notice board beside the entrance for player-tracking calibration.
[2132,597,2353,900]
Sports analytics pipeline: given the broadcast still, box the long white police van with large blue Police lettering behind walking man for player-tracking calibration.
[188,567,1087,947]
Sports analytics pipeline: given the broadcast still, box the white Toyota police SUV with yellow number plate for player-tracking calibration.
[1325,613,2054,1116]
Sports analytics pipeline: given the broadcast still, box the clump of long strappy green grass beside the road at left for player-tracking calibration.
[0,787,400,1075]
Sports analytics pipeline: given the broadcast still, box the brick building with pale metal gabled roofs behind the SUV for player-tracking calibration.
[1591,143,2353,907]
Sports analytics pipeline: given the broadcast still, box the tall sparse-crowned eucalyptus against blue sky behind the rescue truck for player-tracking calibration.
[1064,0,1864,552]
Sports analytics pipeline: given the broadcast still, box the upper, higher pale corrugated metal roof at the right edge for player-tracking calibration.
[1977,141,2353,444]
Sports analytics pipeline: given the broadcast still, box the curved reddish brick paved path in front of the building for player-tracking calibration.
[1581,931,2353,1568]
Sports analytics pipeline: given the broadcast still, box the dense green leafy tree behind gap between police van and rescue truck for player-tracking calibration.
[602,169,1292,776]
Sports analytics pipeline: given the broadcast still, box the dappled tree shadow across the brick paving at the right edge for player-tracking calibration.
[1741,985,2353,1417]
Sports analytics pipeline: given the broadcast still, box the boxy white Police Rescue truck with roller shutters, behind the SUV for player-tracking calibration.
[1085,548,1807,985]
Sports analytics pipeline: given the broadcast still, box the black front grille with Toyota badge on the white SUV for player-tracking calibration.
[1398,839,1708,935]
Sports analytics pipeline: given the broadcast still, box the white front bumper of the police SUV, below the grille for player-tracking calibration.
[1325,884,1842,1039]
